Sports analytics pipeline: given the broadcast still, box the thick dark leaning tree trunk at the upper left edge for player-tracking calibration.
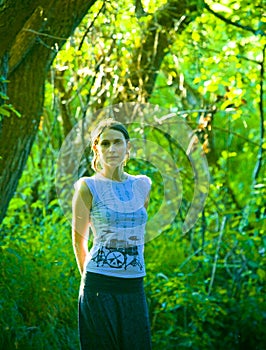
[0,0,96,222]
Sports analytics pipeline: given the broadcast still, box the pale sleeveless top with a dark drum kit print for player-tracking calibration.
[75,173,151,278]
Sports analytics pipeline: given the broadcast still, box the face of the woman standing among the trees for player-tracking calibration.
[94,129,130,168]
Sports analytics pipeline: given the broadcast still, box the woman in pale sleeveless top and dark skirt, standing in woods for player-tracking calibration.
[72,119,151,350]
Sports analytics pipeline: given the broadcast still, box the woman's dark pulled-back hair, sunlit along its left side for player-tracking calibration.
[91,118,130,171]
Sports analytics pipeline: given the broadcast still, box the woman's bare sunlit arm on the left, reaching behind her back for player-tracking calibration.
[72,181,92,275]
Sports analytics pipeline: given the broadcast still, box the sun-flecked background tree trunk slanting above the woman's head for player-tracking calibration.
[118,0,198,102]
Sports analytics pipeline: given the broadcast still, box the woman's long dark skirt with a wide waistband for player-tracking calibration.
[79,272,151,350]
